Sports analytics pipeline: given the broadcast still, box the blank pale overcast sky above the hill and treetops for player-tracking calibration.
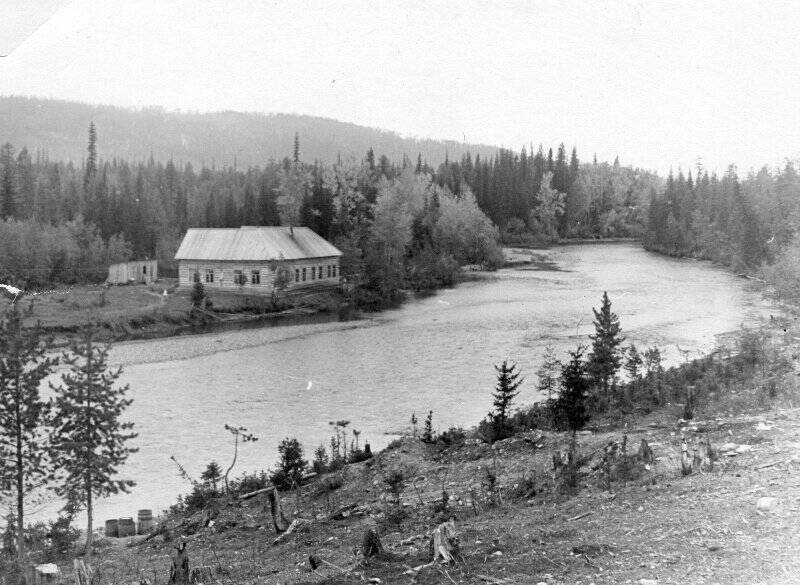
[0,0,800,173]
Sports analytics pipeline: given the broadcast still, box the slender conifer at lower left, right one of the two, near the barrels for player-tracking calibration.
[53,325,137,560]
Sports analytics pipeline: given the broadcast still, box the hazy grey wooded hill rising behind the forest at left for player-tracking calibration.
[0,96,497,168]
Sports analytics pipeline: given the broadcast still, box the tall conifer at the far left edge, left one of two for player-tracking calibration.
[0,303,57,568]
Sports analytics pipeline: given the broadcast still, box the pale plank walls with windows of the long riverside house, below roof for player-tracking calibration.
[178,256,339,294]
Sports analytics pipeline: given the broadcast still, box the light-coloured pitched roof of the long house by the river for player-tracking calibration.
[175,226,342,261]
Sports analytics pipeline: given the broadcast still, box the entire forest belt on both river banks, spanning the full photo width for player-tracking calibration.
[0,101,800,304]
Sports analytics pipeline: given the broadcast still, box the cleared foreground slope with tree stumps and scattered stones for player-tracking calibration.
[39,314,800,585]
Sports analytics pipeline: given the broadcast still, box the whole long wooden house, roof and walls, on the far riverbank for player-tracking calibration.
[175,226,342,294]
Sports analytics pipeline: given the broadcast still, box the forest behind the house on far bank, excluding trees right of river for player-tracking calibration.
[0,123,658,297]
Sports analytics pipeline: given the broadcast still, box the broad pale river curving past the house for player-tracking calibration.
[48,243,777,524]
